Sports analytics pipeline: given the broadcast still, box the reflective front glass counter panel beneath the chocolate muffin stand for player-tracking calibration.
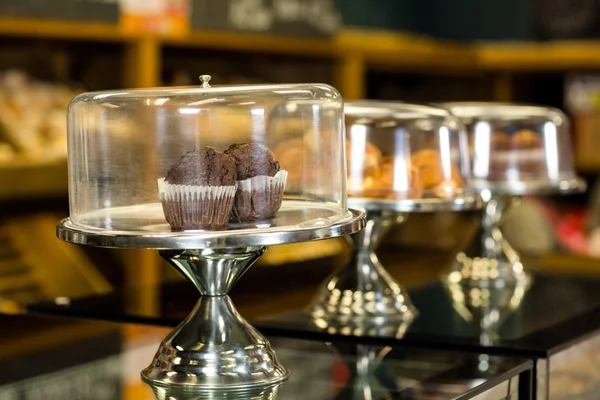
[0,316,532,400]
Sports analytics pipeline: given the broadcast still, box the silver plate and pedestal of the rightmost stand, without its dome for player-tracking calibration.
[443,178,586,288]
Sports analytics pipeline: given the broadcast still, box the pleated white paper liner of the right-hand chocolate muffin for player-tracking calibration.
[231,170,288,222]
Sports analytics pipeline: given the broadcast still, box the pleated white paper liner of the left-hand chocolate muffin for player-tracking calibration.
[158,178,236,230]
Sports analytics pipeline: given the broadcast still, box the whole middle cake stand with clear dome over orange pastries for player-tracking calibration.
[271,100,480,324]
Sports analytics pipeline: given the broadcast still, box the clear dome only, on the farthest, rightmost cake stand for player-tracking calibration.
[443,102,585,194]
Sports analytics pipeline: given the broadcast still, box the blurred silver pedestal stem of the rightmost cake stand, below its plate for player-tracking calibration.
[445,196,530,288]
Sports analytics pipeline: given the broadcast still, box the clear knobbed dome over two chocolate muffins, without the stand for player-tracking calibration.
[68,79,353,244]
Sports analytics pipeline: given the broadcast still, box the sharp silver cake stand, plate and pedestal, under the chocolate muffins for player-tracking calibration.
[57,208,364,390]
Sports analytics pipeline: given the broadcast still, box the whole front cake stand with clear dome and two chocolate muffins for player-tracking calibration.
[57,76,364,389]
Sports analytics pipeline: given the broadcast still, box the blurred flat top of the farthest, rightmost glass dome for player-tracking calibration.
[439,101,565,119]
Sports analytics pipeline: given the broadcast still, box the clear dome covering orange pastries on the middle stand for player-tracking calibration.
[345,100,474,211]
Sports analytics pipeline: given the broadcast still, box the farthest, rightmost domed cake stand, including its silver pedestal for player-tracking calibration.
[444,103,586,286]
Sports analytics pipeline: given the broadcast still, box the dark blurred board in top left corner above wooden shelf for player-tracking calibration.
[0,0,119,25]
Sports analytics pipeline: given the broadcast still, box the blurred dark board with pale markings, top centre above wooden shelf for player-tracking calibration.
[191,0,341,37]
